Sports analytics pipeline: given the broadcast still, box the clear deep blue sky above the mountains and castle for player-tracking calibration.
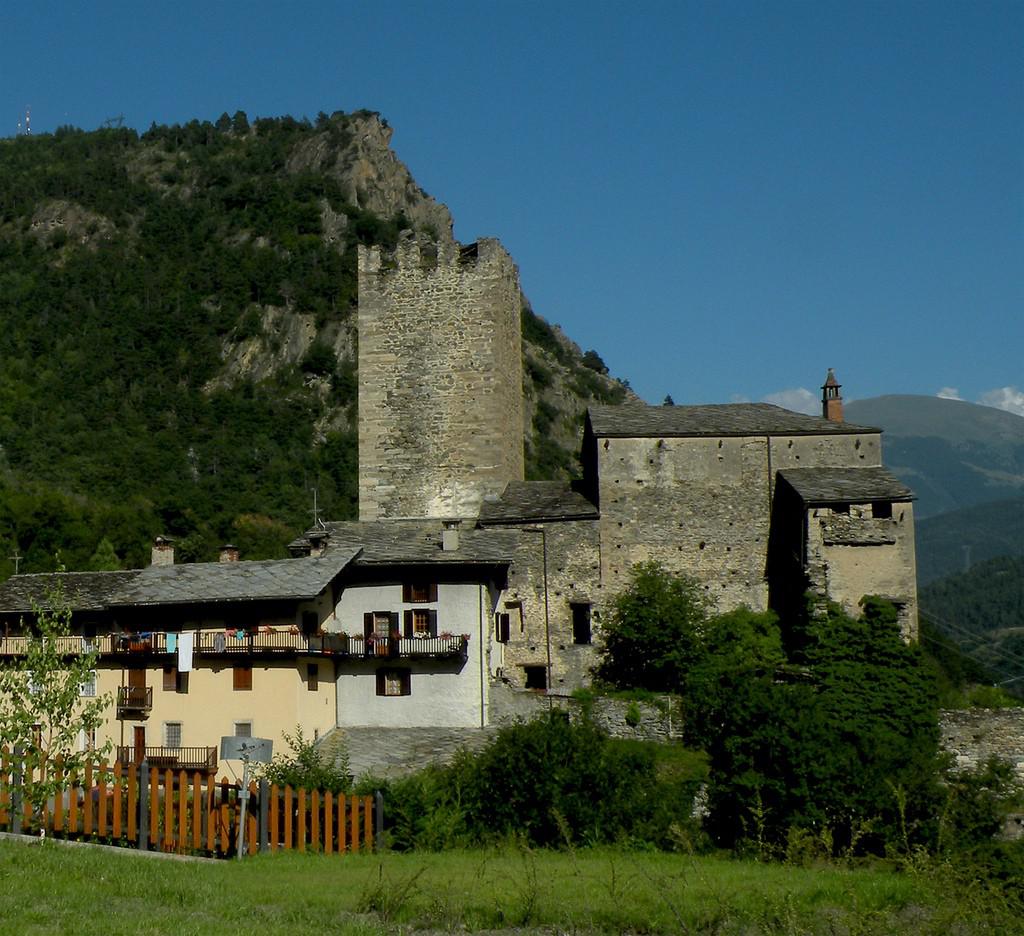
[0,0,1024,415]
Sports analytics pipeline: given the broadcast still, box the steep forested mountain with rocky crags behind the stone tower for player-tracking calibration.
[0,112,628,578]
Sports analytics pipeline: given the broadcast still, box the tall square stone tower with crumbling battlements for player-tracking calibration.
[358,239,523,520]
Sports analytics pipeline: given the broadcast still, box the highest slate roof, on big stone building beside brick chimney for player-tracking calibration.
[587,403,882,438]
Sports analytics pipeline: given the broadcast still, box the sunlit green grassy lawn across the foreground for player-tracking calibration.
[0,841,1022,936]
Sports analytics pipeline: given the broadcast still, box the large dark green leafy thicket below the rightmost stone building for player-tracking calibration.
[708,599,939,851]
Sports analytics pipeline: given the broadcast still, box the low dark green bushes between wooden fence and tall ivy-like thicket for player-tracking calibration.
[358,712,700,850]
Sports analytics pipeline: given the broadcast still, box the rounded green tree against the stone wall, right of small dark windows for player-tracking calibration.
[595,562,711,692]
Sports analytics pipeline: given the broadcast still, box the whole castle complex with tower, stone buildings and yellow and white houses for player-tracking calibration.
[0,239,916,770]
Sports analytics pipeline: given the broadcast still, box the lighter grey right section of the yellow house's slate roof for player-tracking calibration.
[110,549,358,606]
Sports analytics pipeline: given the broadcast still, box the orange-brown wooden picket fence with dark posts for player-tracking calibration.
[0,749,383,858]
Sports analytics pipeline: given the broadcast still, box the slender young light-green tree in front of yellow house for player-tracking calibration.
[0,583,112,814]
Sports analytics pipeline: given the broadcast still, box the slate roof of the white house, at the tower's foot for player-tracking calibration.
[289,520,519,565]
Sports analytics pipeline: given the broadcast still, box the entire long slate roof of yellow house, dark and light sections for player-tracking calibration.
[0,550,357,613]
